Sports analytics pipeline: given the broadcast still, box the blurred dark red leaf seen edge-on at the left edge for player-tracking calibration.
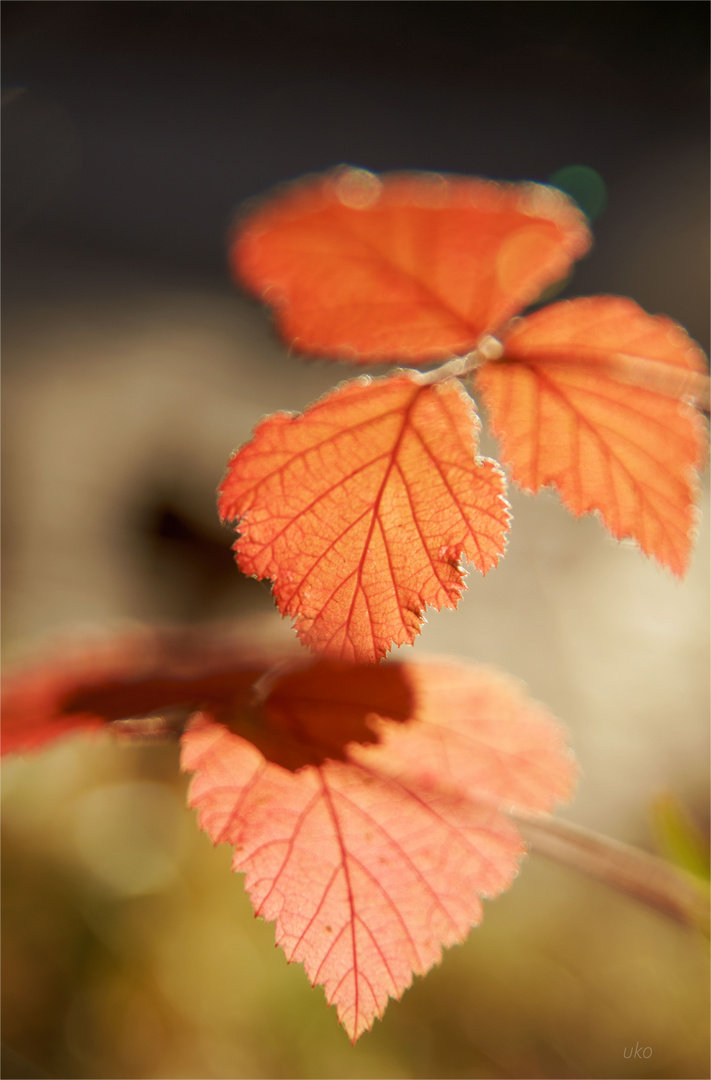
[1,625,281,755]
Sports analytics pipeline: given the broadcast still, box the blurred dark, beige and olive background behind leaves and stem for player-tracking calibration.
[2,0,709,1080]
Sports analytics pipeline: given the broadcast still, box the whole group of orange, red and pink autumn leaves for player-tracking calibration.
[2,168,708,1040]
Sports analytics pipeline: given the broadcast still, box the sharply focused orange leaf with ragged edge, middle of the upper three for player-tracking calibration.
[218,373,508,662]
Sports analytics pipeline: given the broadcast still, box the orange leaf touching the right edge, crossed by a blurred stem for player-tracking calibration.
[475,296,705,576]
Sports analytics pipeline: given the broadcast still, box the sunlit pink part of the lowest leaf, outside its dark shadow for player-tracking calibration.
[182,660,575,1041]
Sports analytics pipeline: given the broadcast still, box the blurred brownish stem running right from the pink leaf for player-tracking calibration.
[512,813,709,936]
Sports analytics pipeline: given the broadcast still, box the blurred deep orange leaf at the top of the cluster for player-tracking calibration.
[231,167,590,364]
